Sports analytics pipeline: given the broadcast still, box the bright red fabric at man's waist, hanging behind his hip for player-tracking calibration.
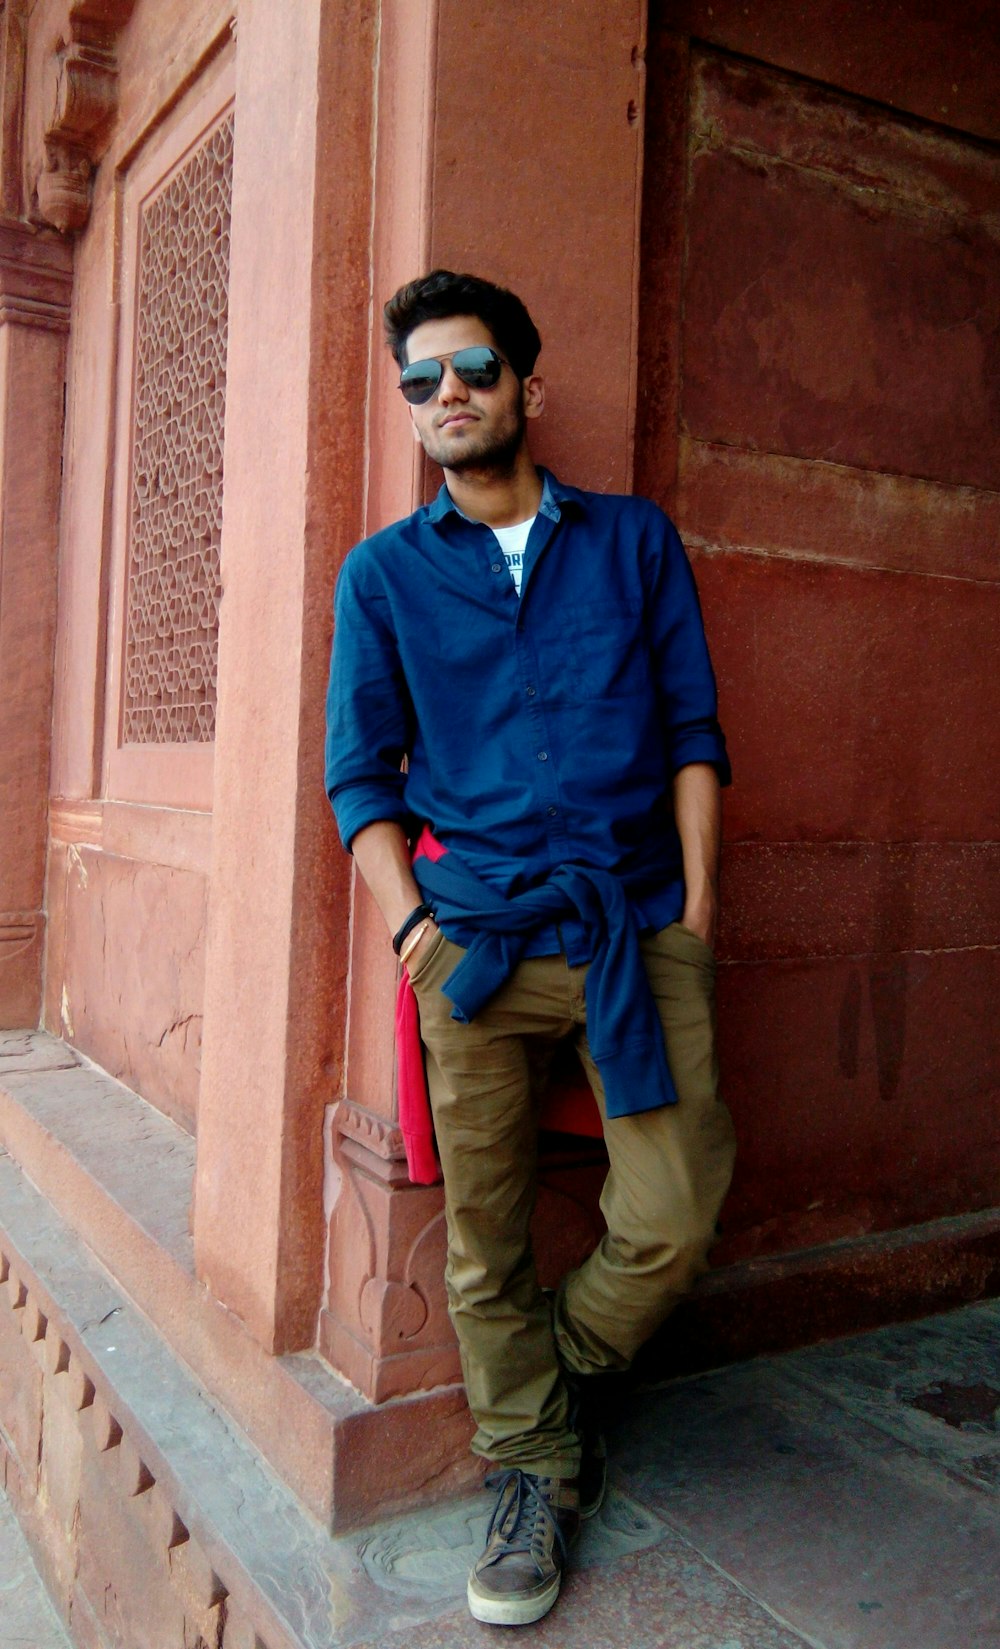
[396,825,604,1186]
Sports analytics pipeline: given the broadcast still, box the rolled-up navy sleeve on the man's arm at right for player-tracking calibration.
[647,510,733,785]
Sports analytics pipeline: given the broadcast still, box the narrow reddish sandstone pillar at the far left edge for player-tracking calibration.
[0,223,73,1027]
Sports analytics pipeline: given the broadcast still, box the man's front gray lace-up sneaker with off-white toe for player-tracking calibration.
[469,1466,579,1626]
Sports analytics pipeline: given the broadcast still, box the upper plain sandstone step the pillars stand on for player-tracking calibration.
[0,1031,469,1527]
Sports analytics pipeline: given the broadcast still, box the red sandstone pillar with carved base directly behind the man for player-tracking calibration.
[320,0,645,1400]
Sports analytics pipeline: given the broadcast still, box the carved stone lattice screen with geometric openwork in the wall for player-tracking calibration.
[122,114,233,744]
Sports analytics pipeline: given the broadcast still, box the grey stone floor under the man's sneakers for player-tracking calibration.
[0,1301,1000,1649]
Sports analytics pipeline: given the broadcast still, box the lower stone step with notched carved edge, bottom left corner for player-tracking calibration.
[0,1154,348,1649]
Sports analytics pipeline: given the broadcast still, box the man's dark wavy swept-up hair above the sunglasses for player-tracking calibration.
[383,269,541,378]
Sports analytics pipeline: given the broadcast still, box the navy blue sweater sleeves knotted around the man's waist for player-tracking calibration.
[413,853,677,1118]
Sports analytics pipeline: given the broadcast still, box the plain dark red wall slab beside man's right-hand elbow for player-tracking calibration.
[696,554,1000,843]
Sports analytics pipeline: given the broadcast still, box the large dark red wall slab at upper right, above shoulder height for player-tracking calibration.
[683,59,1000,488]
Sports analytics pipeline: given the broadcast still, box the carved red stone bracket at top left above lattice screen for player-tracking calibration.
[35,0,135,234]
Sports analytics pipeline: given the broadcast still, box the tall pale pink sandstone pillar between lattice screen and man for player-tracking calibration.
[195,0,375,1351]
